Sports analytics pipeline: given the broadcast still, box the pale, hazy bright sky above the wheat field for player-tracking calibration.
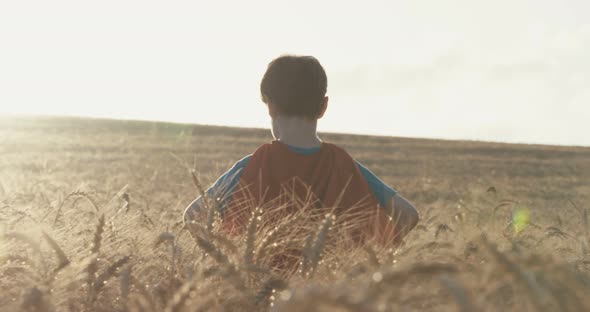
[0,0,590,146]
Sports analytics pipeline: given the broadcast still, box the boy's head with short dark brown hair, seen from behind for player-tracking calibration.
[260,55,328,119]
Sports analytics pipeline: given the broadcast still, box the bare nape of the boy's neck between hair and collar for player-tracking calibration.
[272,116,322,148]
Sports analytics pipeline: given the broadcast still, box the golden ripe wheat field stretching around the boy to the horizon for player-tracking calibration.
[0,117,590,311]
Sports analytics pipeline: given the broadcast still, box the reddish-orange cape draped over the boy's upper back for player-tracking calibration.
[224,141,379,231]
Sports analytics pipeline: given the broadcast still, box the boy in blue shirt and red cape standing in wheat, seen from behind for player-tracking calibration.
[184,55,418,243]
